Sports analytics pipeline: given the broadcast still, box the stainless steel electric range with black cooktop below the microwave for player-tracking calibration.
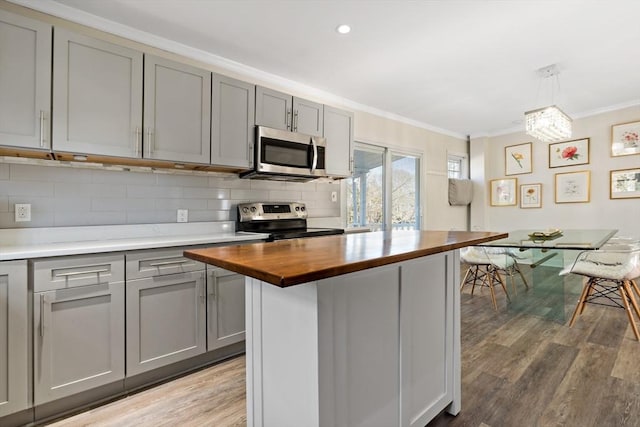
[236,202,344,241]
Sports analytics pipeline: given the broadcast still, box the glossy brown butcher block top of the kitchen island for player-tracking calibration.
[184,231,508,288]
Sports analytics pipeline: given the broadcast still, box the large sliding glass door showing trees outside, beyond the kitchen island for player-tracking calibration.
[345,143,421,231]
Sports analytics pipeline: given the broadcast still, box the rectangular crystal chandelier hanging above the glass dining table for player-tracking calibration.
[524,64,571,142]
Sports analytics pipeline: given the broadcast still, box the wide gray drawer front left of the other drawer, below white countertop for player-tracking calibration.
[30,254,124,292]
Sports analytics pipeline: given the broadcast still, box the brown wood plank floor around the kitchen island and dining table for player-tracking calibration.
[45,270,640,427]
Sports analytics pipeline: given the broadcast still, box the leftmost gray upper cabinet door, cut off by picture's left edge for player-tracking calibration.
[0,10,51,149]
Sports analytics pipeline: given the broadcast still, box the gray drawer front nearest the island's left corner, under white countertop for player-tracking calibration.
[127,248,205,280]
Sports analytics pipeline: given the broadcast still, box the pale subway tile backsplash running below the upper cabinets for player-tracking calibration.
[0,163,340,228]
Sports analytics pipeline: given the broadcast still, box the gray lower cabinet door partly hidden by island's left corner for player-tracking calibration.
[207,266,245,350]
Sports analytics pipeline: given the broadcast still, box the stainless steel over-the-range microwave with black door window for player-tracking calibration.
[240,126,326,182]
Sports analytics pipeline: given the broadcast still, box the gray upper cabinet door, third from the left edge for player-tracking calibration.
[143,55,211,164]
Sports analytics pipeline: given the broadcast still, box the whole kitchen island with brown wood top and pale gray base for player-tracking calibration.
[185,231,507,427]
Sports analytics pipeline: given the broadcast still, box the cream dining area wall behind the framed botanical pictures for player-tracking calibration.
[471,106,640,236]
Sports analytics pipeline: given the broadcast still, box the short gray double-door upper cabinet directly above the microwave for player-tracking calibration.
[256,86,323,136]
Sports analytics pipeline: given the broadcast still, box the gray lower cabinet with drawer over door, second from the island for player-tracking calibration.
[126,248,206,376]
